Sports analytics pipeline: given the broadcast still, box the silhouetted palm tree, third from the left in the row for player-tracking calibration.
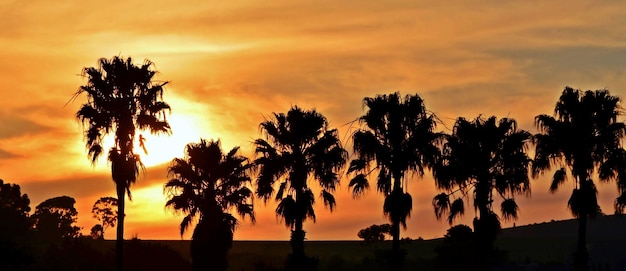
[254,106,347,270]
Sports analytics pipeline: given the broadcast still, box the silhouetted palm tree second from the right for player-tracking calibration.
[433,116,532,270]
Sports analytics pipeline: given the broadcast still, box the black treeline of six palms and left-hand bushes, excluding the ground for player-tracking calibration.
[0,56,626,271]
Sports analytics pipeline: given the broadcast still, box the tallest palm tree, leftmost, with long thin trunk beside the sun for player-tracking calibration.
[73,56,170,270]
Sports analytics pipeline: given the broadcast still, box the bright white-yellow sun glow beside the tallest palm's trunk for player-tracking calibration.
[134,112,201,167]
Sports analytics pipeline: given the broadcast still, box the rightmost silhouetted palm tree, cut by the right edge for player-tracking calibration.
[533,87,626,270]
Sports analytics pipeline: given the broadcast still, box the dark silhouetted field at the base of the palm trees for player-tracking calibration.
[90,216,626,271]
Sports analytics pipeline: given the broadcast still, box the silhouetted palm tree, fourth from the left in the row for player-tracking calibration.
[348,92,441,270]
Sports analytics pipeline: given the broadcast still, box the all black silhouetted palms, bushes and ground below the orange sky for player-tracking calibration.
[0,73,626,271]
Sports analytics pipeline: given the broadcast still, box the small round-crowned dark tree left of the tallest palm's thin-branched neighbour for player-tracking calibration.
[32,196,80,241]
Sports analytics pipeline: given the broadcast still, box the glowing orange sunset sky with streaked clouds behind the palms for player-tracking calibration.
[0,0,626,240]
